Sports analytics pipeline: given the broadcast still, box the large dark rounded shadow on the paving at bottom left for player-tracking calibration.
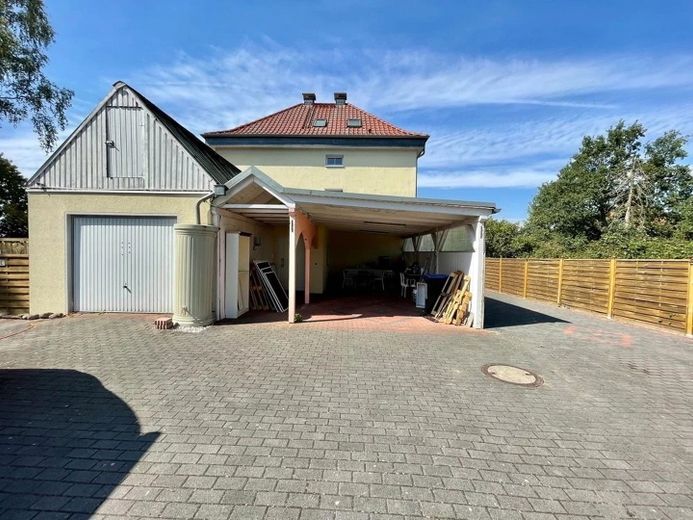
[0,369,159,518]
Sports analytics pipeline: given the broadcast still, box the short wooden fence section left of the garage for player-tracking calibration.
[0,238,29,314]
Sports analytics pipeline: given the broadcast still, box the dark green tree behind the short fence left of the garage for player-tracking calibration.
[0,154,29,238]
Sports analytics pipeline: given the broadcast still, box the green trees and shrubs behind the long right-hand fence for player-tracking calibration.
[486,121,693,258]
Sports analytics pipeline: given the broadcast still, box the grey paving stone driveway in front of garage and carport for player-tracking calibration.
[0,296,693,520]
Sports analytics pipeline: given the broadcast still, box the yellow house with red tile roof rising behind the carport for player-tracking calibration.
[203,92,428,197]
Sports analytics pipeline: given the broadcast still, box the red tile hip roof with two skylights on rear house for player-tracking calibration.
[203,103,428,137]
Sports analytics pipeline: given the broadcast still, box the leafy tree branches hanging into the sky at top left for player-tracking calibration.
[0,0,73,151]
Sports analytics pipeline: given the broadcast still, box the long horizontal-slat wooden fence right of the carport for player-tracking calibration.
[485,258,693,335]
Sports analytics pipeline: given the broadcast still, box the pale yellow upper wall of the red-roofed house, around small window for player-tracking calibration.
[215,147,418,197]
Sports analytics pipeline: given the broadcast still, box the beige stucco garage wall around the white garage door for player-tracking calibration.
[29,192,209,313]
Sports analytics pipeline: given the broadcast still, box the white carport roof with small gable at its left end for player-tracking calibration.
[212,166,497,237]
